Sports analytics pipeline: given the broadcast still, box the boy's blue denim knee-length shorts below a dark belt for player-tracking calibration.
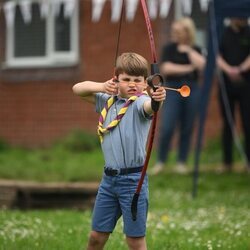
[92,173,148,237]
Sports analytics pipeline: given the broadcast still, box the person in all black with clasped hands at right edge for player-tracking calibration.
[217,18,250,170]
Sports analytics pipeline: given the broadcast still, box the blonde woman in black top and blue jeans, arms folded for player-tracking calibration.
[151,17,205,174]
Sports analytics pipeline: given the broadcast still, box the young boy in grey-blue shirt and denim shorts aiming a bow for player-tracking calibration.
[73,53,166,250]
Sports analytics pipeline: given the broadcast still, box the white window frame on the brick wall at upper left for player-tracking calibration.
[4,0,79,68]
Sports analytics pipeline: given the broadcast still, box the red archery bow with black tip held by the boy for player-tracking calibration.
[131,0,162,221]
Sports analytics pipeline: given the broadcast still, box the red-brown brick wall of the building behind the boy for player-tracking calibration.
[0,1,223,147]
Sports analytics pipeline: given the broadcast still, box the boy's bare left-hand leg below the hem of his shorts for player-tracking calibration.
[87,231,110,250]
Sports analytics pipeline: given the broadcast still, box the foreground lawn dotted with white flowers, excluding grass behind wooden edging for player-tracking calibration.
[0,173,250,250]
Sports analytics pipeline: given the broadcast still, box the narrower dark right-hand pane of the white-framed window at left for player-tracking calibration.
[55,4,70,51]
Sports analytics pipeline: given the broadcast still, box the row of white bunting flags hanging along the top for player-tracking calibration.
[0,0,211,26]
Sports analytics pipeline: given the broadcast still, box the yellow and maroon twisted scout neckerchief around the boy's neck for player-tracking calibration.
[97,95,140,142]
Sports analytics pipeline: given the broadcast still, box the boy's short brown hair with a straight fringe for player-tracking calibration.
[115,52,149,79]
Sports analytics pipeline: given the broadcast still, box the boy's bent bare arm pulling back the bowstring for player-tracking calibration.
[72,79,117,103]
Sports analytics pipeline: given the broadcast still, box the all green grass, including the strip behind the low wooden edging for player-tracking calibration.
[0,134,250,250]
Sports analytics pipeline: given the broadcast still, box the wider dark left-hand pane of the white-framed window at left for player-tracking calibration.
[14,3,46,57]
